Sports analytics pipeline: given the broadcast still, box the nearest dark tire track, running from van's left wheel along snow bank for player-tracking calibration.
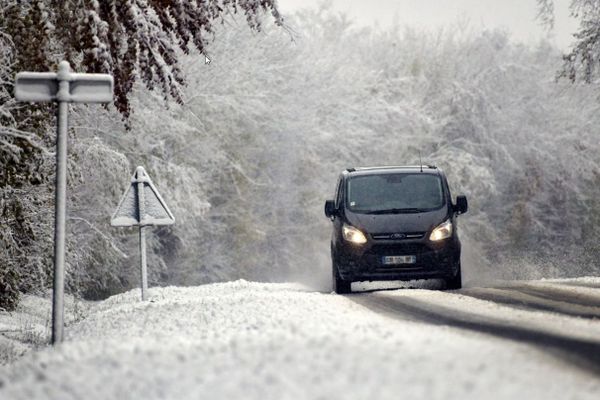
[348,292,600,376]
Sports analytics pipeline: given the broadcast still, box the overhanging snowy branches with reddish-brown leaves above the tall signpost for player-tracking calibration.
[0,0,282,116]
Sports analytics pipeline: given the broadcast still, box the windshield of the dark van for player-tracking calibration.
[346,173,444,214]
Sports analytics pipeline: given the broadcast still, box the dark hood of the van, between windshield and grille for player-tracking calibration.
[346,207,449,234]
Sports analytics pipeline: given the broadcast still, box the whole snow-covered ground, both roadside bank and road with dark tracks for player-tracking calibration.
[0,278,600,400]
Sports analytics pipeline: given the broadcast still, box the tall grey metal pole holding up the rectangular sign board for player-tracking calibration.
[52,61,70,344]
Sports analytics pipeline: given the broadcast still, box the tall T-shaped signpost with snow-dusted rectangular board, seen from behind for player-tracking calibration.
[15,61,113,344]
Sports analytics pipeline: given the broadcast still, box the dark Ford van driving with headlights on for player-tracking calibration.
[325,166,468,293]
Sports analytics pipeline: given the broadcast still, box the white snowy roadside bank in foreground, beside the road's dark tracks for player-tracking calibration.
[0,281,600,400]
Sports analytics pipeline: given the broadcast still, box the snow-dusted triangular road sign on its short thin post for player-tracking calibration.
[110,167,175,301]
